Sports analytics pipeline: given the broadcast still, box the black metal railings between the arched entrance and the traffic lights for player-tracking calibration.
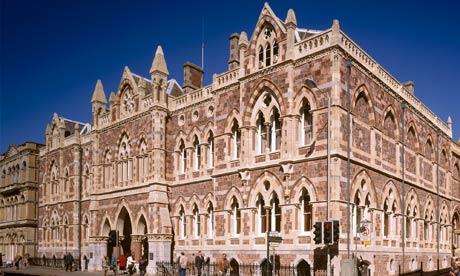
[157,262,302,276]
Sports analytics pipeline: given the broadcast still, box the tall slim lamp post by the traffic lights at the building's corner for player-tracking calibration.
[305,78,331,276]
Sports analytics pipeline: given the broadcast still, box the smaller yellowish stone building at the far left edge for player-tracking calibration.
[0,142,43,262]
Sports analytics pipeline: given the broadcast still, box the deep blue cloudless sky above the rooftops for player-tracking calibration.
[0,0,460,153]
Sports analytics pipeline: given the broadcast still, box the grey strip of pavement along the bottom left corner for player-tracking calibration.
[0,266,105,276]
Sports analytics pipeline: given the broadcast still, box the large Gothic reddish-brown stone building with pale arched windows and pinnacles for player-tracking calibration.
[39,4,460,275]
